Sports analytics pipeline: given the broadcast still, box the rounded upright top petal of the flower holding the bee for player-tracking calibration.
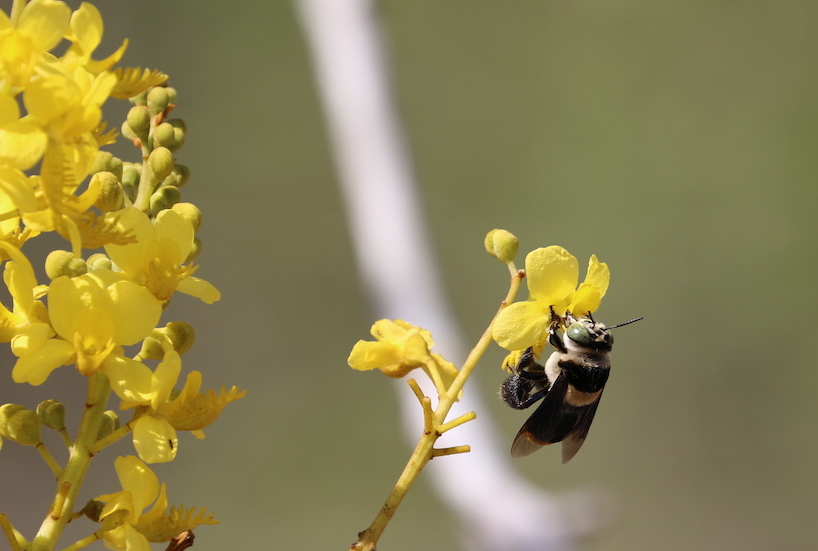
[525,245,579,306]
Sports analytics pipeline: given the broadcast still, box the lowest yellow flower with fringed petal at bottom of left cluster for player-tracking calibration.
[96,455,218,551]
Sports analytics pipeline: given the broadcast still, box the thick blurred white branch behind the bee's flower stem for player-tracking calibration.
[296,0,605,551]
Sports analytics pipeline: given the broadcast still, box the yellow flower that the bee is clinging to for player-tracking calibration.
[492,245,611,351]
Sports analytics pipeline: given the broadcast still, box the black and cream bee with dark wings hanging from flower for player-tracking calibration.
[500,313,642,463]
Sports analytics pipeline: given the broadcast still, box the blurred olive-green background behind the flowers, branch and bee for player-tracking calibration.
[0,0,818,551]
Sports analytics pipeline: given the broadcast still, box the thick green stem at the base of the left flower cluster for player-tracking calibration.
[27,372,111,551]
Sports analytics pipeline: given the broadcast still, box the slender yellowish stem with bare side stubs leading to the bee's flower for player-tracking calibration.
[350,264,525,551]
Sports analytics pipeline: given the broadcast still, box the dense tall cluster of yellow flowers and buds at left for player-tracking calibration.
[0,0,244,549]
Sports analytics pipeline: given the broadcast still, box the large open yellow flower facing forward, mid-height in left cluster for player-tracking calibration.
[12,270,162,385]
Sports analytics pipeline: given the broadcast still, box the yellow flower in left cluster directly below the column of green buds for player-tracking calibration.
[105,207,221,304]
